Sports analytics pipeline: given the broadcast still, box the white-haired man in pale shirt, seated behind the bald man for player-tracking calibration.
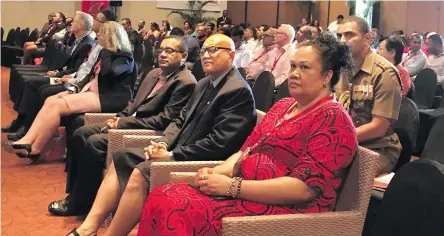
[267,24,295,88]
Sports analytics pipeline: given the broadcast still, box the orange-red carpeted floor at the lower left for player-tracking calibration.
[0,67,136,236]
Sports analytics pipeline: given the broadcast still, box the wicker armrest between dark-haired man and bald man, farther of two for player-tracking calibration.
[106,129,162,167]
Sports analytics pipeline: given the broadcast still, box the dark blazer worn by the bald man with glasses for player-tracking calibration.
[156,67,256,161]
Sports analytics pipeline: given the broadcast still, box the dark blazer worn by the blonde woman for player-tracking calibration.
[99,48,134,113]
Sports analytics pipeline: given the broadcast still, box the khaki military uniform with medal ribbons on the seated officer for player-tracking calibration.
[335,50,402,175]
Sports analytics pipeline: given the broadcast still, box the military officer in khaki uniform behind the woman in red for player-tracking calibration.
[335,16,402,175]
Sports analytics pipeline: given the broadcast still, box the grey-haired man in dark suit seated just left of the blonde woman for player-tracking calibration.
[2,11,94,140]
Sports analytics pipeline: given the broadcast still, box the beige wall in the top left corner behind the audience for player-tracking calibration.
[0,1,81,32]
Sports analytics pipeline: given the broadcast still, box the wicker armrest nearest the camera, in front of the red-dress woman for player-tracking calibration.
[222,211,365,236]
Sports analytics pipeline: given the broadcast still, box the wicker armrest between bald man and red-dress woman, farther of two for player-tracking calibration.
[150,161,223,191]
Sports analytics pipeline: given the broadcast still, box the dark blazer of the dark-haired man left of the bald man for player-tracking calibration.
[117,66,197,131]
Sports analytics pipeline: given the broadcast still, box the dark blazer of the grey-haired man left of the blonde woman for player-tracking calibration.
[57,35,94,77]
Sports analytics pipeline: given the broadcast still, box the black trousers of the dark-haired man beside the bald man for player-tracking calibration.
[67,124,108,210]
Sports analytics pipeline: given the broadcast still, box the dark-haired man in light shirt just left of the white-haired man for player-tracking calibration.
[246,28,277,80]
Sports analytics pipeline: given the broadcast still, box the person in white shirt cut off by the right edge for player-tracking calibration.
[426,34,444,85]
